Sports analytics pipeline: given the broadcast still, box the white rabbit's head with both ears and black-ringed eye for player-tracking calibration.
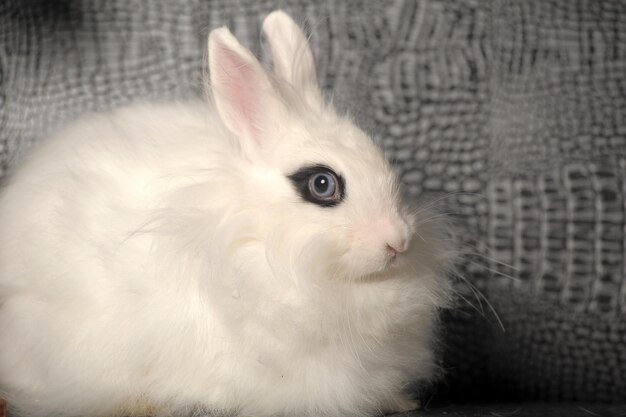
[209,11,424,280]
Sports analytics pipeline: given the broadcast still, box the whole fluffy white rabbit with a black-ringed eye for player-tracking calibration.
[0,11,451,417]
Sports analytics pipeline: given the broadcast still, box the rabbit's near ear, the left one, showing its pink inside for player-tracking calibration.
[209,27,281,153]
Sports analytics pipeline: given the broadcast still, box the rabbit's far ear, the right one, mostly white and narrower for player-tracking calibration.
[263,10,318,91]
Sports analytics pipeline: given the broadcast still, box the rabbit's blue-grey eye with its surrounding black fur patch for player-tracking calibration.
[288,165,346,207]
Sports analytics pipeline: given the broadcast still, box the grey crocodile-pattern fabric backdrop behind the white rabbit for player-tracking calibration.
[0,0,626,402]
